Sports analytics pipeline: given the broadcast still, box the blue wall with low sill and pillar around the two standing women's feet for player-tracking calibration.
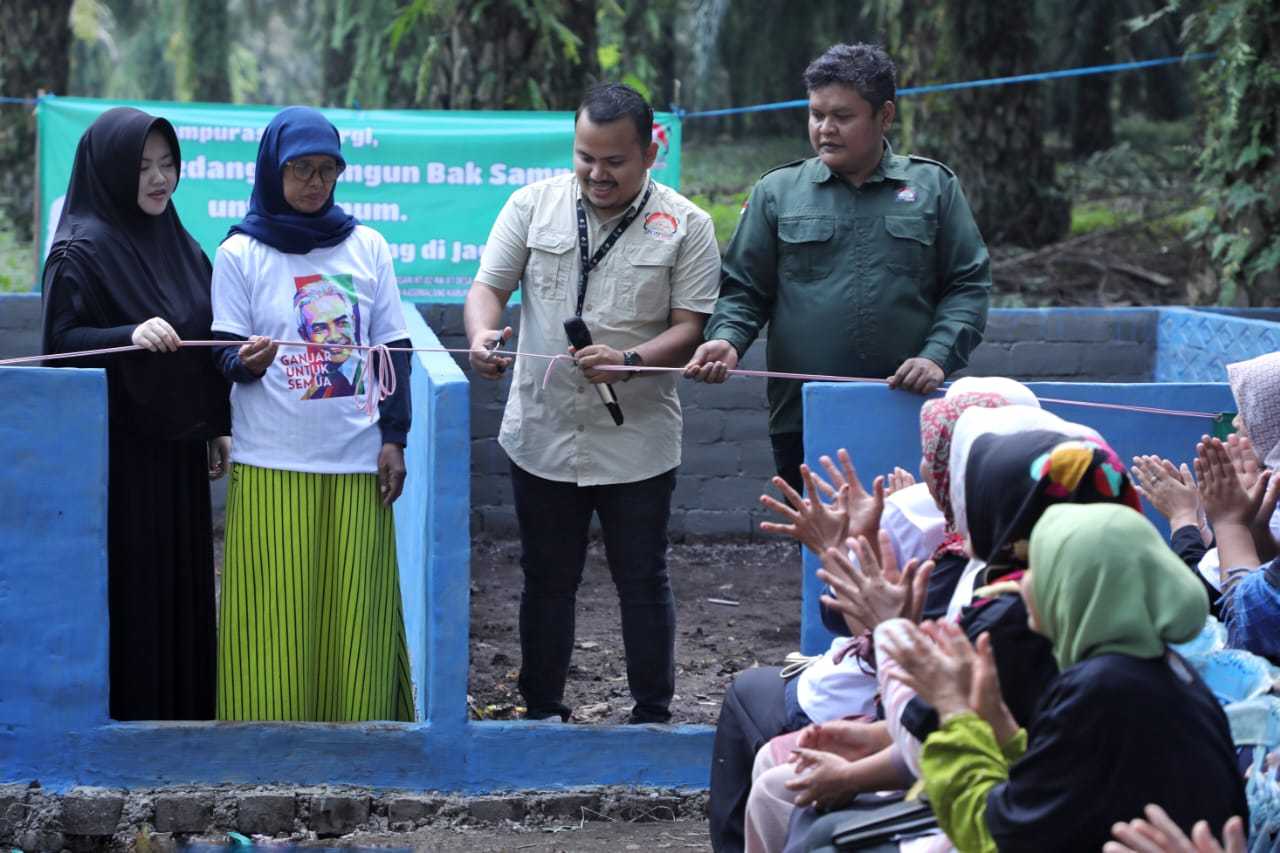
[0,302,712,793]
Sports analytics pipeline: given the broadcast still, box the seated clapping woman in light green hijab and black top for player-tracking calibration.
[877,506,1245,852]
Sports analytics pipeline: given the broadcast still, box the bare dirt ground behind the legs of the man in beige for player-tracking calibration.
[470,539,800,724]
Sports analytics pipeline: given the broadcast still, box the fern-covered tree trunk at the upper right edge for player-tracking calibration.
[1166,0,1280,305]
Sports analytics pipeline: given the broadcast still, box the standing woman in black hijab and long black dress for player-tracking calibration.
[44,108,230,720]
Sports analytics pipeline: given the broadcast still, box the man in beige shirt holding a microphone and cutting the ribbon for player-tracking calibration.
[465,83,719,722]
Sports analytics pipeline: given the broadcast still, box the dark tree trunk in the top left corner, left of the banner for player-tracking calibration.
[0,0,72,244]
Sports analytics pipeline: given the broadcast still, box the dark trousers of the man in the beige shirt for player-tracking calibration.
[511,462,676,722]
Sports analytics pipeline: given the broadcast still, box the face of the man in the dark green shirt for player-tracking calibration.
[809,83,895,179]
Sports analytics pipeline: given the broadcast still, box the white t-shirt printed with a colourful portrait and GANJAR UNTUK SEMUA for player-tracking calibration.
[212,225,408,474]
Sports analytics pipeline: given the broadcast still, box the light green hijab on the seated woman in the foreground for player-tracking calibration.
[1030,503,1208,670]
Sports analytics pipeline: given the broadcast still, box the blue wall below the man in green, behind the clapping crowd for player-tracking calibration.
[800,382,1233,654]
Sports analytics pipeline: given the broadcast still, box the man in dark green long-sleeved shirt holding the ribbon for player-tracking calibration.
[685,44,991,491]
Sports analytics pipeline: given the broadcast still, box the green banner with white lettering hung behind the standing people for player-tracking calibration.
[36,97,681,302]
